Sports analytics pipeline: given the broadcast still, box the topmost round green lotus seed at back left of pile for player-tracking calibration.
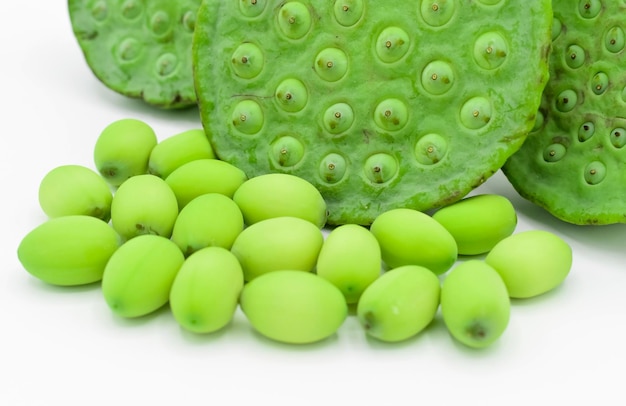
[94,118,157,186]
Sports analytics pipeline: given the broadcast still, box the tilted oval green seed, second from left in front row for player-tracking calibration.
[102,234,185,318]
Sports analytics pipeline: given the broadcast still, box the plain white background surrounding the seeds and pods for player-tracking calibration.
[0,0,626,406]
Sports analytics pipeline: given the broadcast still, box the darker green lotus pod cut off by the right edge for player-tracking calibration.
[502,0,626,225]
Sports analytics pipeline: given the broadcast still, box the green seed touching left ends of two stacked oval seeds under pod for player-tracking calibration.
[172,193,244,256]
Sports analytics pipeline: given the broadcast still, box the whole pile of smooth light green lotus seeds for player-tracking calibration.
[17,118,572,348]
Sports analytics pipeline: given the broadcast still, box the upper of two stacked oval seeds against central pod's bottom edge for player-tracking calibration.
[233,173,326,228]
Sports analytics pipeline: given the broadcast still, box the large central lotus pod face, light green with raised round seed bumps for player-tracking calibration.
[192,0,552,225]
